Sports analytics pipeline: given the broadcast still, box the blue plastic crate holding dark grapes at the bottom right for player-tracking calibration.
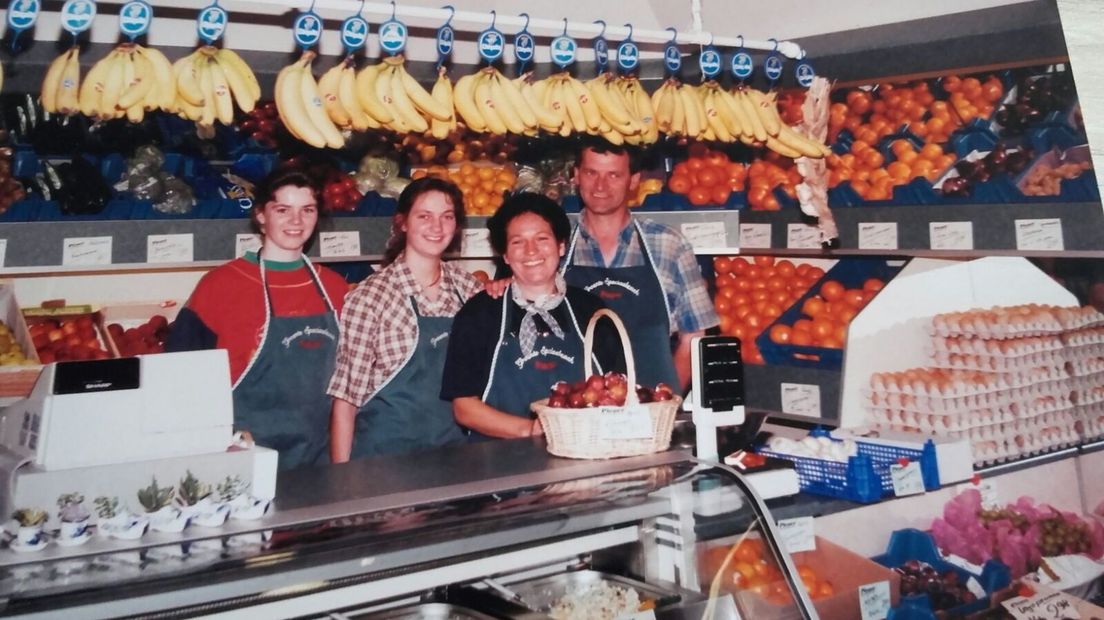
[871,528,1012,620]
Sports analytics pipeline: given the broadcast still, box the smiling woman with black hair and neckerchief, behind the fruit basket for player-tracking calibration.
[440,193,624,440]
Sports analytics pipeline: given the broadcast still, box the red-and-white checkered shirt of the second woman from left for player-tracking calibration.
[326,257,482,406]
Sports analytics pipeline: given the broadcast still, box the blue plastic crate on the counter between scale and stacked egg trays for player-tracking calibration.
[756,429,940,504]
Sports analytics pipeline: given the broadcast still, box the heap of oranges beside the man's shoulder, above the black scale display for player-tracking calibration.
[713,256,825,364]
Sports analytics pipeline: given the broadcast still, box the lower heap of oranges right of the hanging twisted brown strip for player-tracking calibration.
[827,139,955,201]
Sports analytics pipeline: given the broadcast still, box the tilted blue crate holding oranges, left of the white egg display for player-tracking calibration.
[755,258,901,370]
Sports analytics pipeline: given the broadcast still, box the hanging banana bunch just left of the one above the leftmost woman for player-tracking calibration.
[166,45,261,129]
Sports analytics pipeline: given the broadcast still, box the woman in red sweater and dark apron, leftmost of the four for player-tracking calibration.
[167,170,347,470]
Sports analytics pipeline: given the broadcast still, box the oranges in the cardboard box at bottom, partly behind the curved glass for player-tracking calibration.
[705,538,836,605]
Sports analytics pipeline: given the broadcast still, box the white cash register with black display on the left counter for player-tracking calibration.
[0,350,277,514]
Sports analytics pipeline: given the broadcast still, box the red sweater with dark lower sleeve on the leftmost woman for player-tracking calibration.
[166,254,348,383]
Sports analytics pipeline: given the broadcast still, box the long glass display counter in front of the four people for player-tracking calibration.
[0,440,817,619]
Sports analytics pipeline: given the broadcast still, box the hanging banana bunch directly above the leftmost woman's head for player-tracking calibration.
[276,50,344,149]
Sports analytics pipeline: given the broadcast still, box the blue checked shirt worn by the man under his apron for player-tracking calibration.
[564,217,719,333]
